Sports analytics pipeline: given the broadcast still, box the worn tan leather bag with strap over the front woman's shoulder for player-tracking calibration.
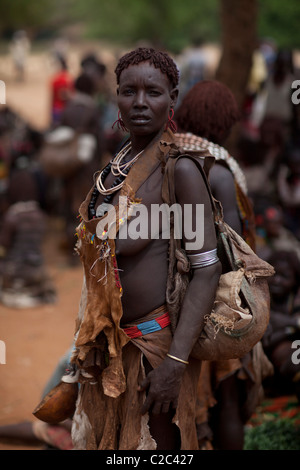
[163,152,274,361]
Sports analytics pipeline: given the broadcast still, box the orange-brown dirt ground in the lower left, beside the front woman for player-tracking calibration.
[0,233,82,450]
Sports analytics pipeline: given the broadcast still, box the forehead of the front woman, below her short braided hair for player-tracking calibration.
[120,62,170,87]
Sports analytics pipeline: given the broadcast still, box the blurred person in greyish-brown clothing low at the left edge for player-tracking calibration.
[0,157,56,308]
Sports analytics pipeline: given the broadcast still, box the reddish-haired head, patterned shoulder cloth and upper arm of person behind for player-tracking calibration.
[175,80,255,249]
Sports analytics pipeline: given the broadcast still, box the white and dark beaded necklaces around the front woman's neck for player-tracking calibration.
[89,143,143,219]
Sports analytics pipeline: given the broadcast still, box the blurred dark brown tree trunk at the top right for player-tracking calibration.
[216,0,258,151]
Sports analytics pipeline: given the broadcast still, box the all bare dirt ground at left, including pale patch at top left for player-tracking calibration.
[0,45,94,450]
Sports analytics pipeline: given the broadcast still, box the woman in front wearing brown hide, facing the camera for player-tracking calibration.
[72,48,220,450]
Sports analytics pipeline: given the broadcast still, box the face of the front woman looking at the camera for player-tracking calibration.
[117,62,178,137]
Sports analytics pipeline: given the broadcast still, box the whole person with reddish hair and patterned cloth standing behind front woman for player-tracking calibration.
[175,80,272,450]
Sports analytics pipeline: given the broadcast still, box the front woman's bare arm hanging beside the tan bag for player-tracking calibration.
[140,158,221,413]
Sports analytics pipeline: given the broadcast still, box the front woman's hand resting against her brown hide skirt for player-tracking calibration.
[138,357,186,414]
